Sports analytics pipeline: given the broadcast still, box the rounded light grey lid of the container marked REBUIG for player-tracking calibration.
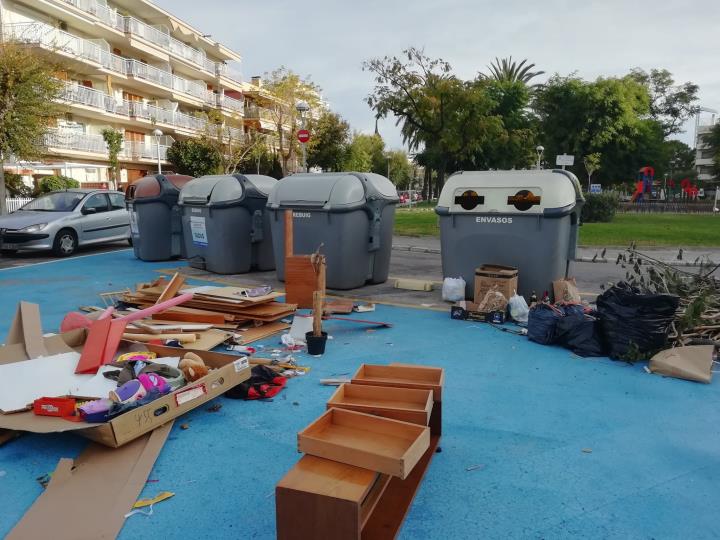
[268,172,398,210]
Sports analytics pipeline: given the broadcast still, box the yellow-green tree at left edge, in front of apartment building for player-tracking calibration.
[0,41,62,215]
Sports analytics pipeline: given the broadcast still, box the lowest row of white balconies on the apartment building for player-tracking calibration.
[43,129,172,161]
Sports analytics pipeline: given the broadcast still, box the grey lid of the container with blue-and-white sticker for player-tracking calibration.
[180,174,277,206]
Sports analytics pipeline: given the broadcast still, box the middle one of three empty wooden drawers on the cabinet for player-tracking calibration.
[327,383,433,426]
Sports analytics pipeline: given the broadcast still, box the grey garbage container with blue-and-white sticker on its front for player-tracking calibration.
[179,174,277,274]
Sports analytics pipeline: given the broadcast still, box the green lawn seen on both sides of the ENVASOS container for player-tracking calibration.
[395,208,720,247]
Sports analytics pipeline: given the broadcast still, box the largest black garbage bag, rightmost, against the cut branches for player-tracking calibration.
[597,282,680,360]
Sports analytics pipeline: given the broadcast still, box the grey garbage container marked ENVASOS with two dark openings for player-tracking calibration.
[435,170,584,298]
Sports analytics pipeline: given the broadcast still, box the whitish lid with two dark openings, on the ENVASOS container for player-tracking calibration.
[436,170,583,215]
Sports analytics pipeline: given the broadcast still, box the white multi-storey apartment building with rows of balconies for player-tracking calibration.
[0,0,252,186]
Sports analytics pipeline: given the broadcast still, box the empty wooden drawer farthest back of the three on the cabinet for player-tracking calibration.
[352,364,445,401]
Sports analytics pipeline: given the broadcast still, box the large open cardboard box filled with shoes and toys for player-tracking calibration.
[0,303,250,448]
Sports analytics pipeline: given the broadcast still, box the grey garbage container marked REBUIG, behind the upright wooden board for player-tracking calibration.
[268,172,399,289]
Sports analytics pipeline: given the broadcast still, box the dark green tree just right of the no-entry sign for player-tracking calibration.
[307,111,350,171]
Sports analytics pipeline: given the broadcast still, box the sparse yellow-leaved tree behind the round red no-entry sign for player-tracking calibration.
[264,66,321,175]
